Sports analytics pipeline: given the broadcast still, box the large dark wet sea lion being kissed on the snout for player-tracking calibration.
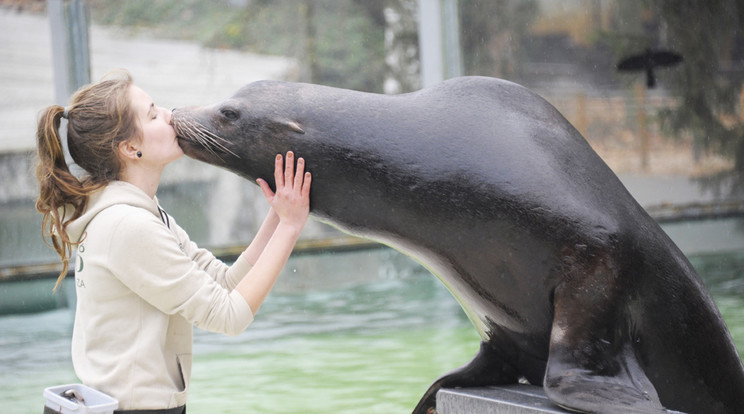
[173,77,744,413]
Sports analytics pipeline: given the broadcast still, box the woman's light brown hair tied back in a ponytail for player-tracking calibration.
[36,70,141,290]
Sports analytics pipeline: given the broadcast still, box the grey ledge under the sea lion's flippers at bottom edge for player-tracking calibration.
[437,384,568,414]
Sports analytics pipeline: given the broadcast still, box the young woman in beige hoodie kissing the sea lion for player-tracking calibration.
[36,72,311,414]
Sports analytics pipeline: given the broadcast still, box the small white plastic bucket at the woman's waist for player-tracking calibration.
[44,384,119,414]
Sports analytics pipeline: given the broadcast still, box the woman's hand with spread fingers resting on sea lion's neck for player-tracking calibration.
[257,151,312,233]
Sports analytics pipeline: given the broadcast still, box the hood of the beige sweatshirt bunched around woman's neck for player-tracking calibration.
[67,181,162,243]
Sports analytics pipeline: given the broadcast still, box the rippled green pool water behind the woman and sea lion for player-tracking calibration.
[0,244,744,414]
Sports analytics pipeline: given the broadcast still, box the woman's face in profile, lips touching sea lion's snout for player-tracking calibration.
[129,85,183,165]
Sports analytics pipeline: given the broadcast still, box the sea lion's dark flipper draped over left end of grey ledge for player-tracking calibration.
[413,342,518,414]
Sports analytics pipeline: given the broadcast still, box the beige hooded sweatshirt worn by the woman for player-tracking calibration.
[68,181,253,410]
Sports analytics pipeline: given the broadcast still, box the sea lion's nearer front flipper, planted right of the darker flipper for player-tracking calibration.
[543,274,667,414]
